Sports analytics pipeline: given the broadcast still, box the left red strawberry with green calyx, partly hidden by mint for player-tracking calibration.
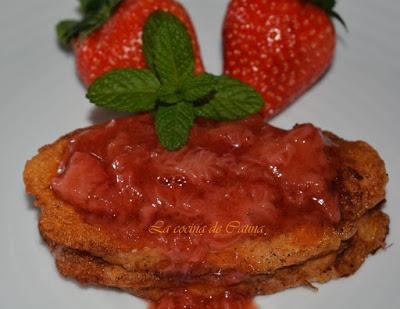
[57,0,204,86]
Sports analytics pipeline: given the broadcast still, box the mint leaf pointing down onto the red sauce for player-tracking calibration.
[155,102,195,151]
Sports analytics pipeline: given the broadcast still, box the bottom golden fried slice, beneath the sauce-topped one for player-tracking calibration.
[53,209,389,300]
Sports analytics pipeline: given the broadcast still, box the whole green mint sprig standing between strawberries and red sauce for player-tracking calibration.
[87,11,264,151]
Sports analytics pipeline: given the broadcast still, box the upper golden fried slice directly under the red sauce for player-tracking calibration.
[24,125,387,273]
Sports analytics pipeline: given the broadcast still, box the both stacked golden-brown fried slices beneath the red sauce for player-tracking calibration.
[24,126,389,300]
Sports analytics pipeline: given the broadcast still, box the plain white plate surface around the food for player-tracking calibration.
[0,0,400,309]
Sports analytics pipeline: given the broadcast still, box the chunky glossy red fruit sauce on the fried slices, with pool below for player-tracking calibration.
[52,115,340,309]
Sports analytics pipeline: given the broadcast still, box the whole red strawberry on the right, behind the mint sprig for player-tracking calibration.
[224,0,345,118]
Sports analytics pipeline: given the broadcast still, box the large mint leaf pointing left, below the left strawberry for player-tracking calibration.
[86,69,160,113]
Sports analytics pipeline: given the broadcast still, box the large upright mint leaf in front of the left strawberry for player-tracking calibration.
[143,11,194,89]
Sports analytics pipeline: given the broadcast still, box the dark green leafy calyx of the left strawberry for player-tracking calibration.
[56,0,122,47]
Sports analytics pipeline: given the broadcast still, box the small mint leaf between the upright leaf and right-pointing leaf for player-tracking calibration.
[179,73,217,102]
